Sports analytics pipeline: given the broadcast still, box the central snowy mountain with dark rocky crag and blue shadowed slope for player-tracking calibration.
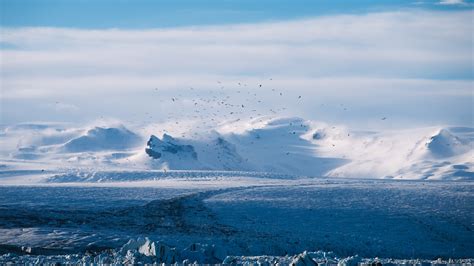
[135,118,345,176]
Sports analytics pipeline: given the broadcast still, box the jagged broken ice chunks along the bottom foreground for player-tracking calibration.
[0,244,474,266]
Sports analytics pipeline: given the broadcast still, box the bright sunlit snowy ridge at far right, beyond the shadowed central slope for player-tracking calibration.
[328,125,474,180]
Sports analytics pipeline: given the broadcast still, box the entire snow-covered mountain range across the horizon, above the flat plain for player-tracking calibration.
[0,117,474,180]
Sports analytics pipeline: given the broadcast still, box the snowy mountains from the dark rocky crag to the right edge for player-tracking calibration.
[136,118,474,179]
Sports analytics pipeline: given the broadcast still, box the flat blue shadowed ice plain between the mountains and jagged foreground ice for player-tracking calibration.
[0,176,474,260]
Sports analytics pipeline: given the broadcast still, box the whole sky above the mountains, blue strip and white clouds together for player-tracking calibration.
[0,0,474,128]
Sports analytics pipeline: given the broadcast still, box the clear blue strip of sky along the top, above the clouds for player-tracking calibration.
[0,0,473,29]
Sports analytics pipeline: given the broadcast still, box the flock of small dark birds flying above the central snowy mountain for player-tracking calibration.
[51,79,387,168]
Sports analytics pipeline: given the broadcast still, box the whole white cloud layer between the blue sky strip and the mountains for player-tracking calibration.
[0,11,473,127]
